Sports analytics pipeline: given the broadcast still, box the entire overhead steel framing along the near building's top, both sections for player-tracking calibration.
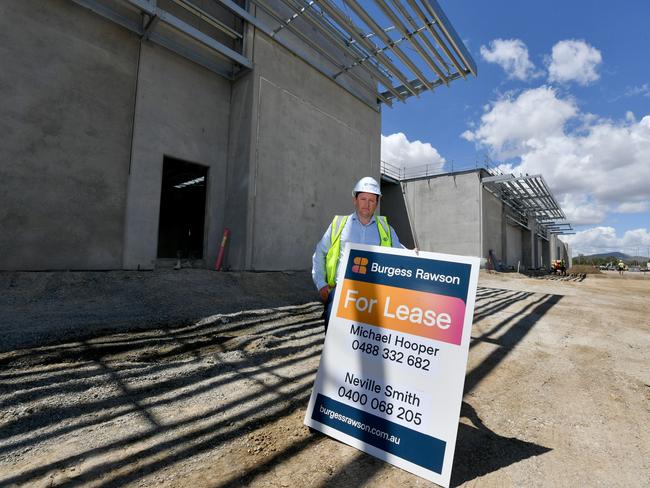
[72,0,477,105]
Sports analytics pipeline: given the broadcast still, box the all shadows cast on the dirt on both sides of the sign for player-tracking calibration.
[0,280,561,487]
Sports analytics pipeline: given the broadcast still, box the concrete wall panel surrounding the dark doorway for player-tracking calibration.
[124,42,230,269]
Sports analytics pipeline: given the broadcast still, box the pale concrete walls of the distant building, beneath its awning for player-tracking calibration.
[382,171,569,271]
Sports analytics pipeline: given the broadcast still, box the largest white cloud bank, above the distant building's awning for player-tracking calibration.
[461,87,650,225]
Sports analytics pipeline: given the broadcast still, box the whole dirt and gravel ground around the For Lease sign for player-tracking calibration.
[0,270,650,488]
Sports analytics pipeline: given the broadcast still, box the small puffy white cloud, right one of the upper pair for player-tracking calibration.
[548,39,603,85]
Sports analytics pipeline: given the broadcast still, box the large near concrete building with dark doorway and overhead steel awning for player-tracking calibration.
[0,0,476,270]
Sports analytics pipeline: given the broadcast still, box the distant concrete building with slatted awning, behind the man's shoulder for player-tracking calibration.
[382,168,571,271]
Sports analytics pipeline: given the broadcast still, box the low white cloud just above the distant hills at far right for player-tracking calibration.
[562,227,650,256]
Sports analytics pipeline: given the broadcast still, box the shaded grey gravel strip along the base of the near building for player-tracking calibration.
[0,268,318,351]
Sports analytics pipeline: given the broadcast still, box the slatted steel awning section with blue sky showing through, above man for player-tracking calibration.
[251,0,477,105]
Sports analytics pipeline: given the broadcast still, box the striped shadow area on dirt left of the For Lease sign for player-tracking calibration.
[0,304,322,487]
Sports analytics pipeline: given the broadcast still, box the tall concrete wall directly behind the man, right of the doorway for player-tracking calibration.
[230,32,380,270]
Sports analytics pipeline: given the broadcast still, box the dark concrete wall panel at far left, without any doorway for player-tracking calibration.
[0,0,138,270]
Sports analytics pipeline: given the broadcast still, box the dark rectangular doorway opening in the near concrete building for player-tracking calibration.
[158,156,208,261]
